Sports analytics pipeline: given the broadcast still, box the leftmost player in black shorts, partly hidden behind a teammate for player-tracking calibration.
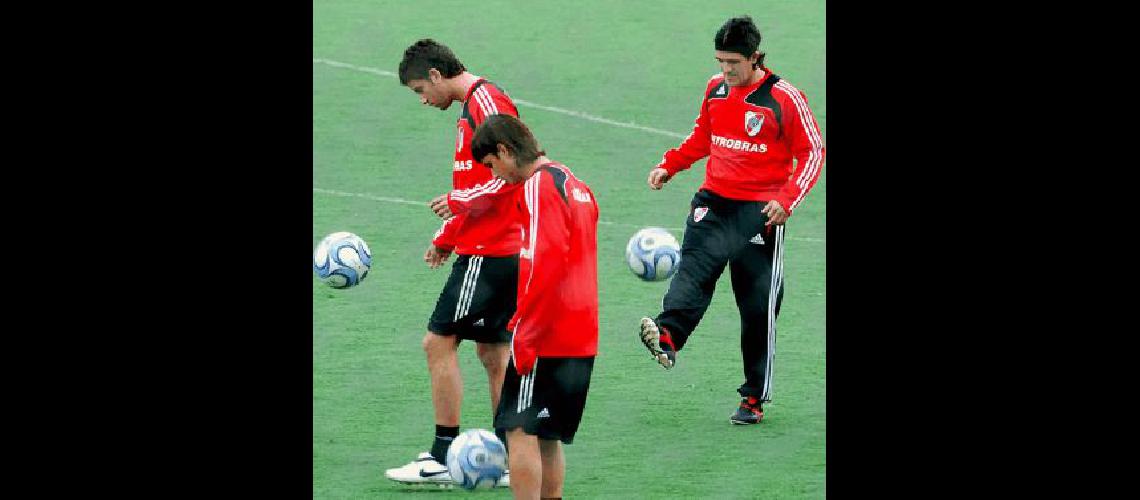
[384,39,522,486]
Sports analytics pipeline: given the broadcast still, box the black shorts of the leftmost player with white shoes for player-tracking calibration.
[428,255,519,343]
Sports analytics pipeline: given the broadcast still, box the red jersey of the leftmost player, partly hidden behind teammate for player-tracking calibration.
[432,79,522,256]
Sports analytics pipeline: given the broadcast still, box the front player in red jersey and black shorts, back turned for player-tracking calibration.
[471,115,597,499]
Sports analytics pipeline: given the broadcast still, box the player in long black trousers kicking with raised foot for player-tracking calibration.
[638,16,824,424]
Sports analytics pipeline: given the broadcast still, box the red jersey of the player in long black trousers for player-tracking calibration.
[658,68,824,215]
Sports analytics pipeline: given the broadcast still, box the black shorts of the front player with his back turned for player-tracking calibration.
[495,358,594,444]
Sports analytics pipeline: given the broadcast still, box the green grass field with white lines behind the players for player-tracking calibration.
[312,0,828,499]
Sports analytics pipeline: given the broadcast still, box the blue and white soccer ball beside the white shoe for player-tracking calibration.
[447,429,506,490]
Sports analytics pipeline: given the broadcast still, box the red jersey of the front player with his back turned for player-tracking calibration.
[507,162,597,375]
